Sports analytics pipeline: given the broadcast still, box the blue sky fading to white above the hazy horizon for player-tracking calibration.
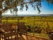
[2,1,53,16]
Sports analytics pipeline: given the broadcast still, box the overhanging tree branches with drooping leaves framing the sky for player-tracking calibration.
[0,0,53,23]
